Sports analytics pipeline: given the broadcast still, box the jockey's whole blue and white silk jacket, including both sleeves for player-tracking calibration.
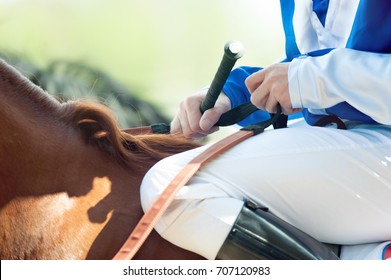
[223,0,391,125]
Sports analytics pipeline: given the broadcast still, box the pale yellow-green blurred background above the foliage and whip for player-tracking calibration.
[0,0,284,128]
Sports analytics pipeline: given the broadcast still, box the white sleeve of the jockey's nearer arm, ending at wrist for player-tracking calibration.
[288,49,391,124]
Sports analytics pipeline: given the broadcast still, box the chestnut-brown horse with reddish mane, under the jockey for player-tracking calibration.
[0,58,200,259]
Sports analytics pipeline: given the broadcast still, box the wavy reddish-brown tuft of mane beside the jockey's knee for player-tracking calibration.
[62,99,199,168]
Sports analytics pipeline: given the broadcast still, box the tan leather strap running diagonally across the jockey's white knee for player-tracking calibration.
[113,130,254,260]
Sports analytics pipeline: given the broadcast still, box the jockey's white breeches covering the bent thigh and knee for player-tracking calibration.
[141,119,391,259]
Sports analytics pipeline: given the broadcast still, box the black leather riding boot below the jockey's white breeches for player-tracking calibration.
[216,203,338,260]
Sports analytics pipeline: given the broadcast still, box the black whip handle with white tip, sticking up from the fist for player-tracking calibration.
[200,41,243,114]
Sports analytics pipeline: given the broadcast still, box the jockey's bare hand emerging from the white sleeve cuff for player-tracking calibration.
[245,63,302,115]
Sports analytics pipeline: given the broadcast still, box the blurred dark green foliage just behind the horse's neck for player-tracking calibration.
[2,55,169,128]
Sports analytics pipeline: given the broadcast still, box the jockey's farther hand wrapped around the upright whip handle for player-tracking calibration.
[171,89,231,139]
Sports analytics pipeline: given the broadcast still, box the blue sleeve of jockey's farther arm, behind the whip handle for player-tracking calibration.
[223,66,270,126]
